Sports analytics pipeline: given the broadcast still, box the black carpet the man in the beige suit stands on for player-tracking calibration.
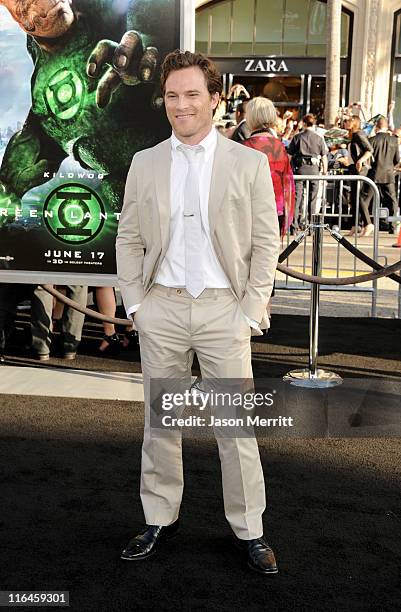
[0,316,401,612]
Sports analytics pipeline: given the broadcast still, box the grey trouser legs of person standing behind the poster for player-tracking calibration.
[31,285,88,355]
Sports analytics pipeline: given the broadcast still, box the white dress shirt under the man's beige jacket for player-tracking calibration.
[127,127,263,334]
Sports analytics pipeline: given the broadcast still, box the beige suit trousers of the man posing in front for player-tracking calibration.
[135,285,266,540]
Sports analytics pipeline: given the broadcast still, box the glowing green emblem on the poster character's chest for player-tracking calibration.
[46,68,84,120]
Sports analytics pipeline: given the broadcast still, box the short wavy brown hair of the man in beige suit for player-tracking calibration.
[160,49,223,95]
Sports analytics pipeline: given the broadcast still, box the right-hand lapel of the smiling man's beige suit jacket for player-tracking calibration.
[208,133,236,237]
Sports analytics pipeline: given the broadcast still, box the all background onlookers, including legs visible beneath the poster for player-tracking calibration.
[0,89,401,362]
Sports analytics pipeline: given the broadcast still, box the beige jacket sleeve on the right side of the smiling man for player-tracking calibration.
[241,155,280,322]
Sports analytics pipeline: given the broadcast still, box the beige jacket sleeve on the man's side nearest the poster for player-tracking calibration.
[116,155,144,310]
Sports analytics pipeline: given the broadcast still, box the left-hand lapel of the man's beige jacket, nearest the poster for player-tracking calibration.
[150,138,171,254]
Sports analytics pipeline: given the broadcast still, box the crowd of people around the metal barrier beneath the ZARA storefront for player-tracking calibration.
[215,84,401,236]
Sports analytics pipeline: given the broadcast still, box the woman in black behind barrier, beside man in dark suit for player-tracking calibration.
[344,115,374,236]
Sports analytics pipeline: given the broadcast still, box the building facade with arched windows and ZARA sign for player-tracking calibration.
[185,0,401,126]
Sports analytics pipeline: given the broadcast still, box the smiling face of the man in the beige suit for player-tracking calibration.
[164,66,219,145]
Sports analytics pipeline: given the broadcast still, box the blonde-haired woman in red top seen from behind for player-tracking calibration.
[243,97,295,236]
